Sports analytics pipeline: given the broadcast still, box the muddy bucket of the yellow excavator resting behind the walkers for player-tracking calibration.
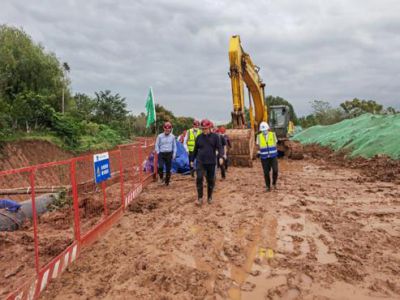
[226,129,255,167]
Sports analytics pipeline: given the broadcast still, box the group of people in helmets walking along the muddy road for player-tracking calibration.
[155,119,278,206]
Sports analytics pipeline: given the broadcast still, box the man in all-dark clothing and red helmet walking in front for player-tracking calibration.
[190,119,223,206]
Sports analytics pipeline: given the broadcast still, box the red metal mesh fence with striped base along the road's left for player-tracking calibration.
[0,138,157,300]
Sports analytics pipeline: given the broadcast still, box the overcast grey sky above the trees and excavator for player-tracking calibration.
[0,0,400,121]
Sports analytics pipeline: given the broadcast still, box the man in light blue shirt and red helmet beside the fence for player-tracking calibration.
[155,122,177,186]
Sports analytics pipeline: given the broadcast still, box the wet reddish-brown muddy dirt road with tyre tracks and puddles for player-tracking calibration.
[43,159,400,299]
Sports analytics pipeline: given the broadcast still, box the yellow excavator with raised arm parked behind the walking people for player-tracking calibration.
[227,35,302,167]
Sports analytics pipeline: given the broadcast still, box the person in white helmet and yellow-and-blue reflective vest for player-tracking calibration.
[257,122,278,192]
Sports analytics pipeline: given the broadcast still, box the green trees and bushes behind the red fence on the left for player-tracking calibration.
[0,25,193,151]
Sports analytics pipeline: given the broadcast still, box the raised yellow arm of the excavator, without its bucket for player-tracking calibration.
[229,35,268,131]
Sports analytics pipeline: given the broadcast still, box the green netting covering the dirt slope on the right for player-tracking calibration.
[293,114,400,159]
